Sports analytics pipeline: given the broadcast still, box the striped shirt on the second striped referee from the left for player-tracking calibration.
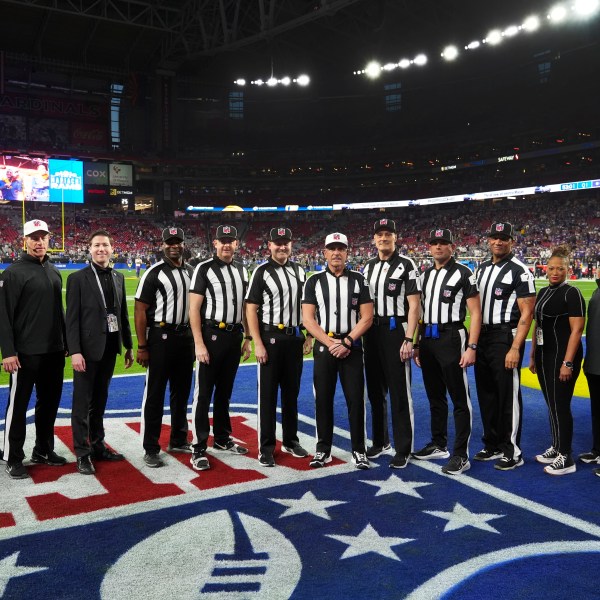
[190,256,248,324]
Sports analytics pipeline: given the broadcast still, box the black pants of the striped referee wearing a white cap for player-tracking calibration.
[313,341,365,454]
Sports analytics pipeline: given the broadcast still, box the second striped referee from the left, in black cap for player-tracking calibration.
[190,225,252,471]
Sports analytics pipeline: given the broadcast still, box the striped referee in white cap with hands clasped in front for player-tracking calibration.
[302,233,373,469]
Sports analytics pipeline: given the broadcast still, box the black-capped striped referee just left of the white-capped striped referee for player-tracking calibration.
[246,227,312,467]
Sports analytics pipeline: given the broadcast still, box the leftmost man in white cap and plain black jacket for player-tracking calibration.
[0,219,67,479]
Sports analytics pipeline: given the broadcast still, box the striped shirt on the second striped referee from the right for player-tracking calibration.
[421,258,479,325]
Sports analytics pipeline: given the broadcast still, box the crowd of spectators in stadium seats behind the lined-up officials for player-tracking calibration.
[0,194,600,276]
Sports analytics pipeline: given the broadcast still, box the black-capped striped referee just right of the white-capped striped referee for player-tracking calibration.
[363,219,421,469]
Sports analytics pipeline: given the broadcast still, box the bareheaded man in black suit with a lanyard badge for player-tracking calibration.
[66,230,133,475]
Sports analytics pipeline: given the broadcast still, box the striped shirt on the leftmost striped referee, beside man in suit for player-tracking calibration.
[135,257,192,325]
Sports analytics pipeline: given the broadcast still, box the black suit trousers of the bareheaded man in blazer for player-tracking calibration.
[71,344,117,457]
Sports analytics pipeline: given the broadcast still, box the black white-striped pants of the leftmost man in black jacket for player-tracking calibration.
[4,352,65,464]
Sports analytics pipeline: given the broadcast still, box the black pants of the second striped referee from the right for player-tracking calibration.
[419,328,473,458]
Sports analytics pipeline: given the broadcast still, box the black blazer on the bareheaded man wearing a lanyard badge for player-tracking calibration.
[66,265,133,361]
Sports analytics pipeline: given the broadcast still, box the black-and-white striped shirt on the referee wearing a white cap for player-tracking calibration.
[302,269,373,335]
